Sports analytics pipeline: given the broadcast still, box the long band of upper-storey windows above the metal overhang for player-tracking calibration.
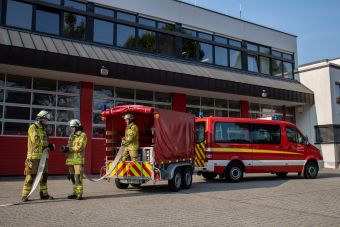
[0,0,295,79]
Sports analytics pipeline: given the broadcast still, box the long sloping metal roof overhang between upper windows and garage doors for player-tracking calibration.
[0,27,314,104]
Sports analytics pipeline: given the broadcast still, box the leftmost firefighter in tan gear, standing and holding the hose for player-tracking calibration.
[22,110,54,202]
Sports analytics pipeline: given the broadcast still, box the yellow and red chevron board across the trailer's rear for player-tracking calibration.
[107,162,152,177]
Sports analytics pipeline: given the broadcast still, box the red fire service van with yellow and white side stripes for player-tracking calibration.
[195,117,323,182]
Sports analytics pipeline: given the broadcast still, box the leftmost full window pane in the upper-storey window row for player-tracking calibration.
[6,0,33,29]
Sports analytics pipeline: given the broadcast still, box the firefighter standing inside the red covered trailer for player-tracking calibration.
[122,113,139,161]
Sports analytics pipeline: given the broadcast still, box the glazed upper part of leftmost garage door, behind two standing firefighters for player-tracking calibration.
[0,74,80,137]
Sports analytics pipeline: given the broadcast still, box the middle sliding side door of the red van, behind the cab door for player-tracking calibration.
[251,123,287,172]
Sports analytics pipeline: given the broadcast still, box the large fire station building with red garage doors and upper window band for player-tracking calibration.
[0,0,314,175]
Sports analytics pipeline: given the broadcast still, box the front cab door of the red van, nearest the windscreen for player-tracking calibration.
[285,126,306,172]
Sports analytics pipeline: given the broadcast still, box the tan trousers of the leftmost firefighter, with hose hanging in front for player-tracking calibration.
[21,159,48,197]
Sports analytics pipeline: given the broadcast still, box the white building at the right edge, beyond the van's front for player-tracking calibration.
[296,58,340,168]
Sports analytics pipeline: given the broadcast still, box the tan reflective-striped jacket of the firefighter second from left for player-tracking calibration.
[66,131,87,165]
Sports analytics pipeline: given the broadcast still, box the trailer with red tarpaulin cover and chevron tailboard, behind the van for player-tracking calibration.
[102,105,195,191]
